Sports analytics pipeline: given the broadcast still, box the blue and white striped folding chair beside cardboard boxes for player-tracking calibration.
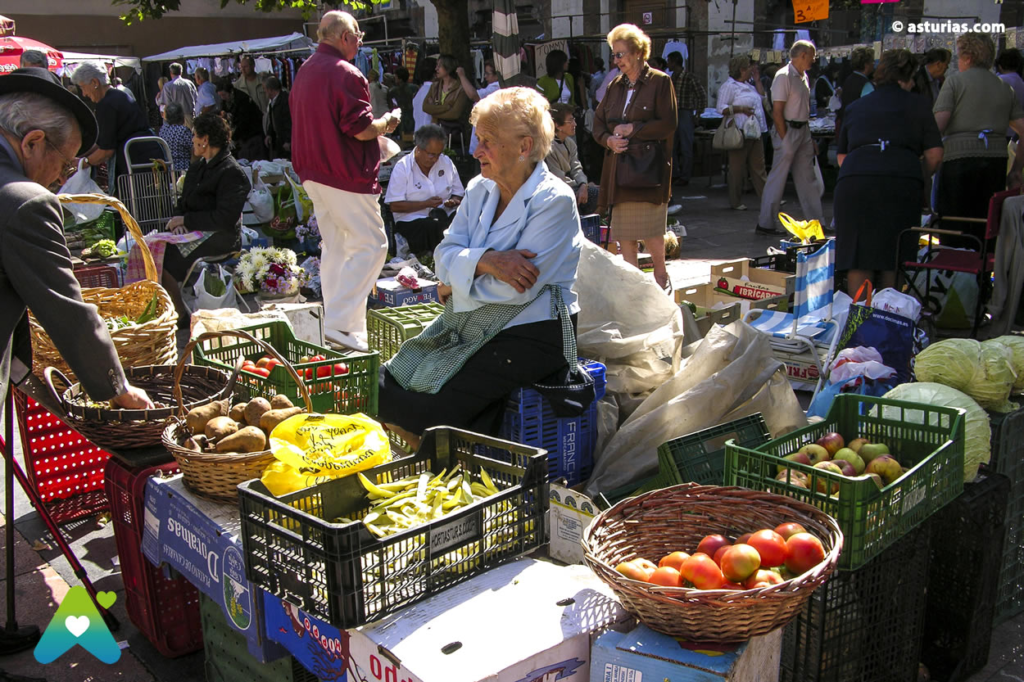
[744,240,838,387]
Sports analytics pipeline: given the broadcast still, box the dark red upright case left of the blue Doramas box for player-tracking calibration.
[106,459,203,658]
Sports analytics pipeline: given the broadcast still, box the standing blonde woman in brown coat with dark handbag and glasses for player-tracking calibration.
[594,24,676,289]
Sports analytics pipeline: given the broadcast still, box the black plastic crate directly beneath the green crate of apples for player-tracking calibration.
[779,524,930,682]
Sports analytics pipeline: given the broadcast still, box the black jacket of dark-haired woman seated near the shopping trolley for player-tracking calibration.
[178,147,249,235]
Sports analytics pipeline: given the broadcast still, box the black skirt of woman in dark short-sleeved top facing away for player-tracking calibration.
[833,175,922,270]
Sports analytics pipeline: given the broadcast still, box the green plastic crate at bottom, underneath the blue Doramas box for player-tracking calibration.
[199,593,319,682]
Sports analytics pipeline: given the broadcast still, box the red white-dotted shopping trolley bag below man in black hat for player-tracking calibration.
[14,390,111,523]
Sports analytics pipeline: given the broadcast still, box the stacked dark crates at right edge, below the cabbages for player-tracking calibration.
[989,409,1024,624]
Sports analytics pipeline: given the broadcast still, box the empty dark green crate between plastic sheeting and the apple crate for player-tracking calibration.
[657,412,771,485]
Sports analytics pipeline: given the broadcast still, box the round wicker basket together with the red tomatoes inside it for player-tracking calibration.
[582,483,843,643]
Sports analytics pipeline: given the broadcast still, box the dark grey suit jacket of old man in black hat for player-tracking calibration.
[0,144,125,400]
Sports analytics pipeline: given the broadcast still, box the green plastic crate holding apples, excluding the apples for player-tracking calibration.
[725,394,966,569]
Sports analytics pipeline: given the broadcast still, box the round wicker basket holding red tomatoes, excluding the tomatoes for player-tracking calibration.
[583,483,843,643]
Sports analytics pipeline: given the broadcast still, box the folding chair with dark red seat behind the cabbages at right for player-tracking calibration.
[897,189,1021,338]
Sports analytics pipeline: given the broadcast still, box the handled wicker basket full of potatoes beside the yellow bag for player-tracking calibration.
[163,330,312,503]
